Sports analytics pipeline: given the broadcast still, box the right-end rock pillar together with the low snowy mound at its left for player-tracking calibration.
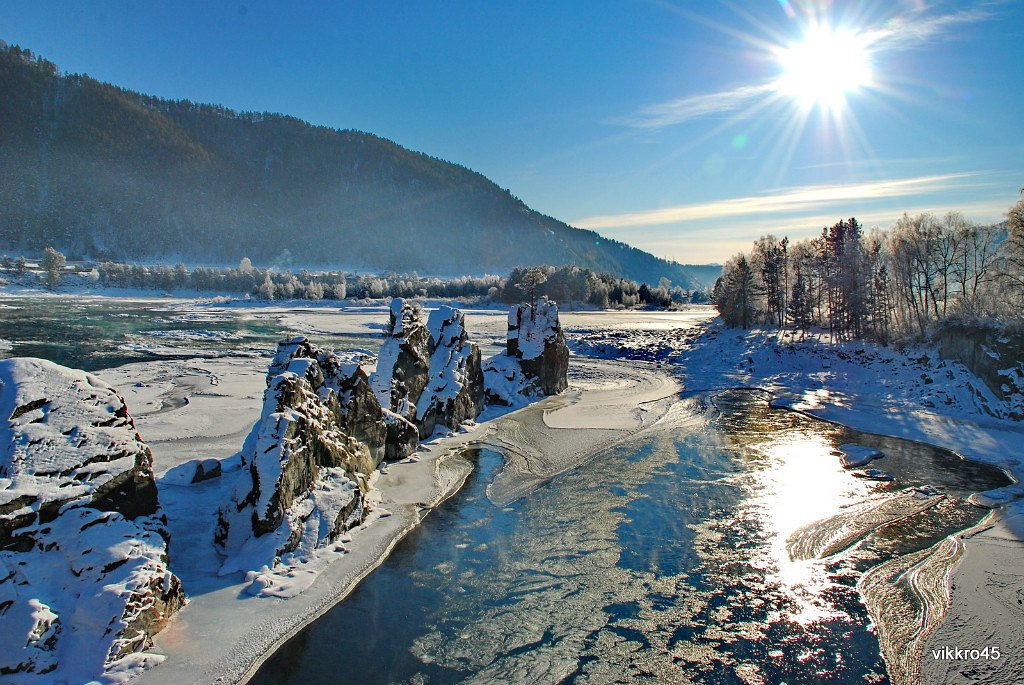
[484,298,569,403]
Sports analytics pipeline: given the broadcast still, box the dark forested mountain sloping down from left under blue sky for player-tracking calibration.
[0,43,712,287]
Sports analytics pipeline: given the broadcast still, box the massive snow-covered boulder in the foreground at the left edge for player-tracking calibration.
[0,358,184,683]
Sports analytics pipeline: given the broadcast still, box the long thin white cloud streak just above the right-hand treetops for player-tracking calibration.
[572,173,978,229]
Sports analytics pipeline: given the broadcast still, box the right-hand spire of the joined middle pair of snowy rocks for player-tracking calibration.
[416,306,484,437]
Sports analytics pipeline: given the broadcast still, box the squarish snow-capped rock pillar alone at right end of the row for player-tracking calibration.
[506,298,569,395]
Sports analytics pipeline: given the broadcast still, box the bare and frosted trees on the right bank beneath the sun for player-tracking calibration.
[712,190,1024,343]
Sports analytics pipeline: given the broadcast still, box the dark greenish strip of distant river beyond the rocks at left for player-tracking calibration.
[0,297,386,371]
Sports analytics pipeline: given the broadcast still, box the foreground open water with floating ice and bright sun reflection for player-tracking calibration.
[251,392,1007,685]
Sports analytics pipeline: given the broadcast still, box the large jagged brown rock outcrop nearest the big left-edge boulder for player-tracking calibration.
[215,338,388,573]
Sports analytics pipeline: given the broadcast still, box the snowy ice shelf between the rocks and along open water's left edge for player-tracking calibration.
[108,331,680,685]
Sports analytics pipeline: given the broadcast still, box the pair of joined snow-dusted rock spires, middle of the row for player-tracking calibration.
[372,298,484,437]
